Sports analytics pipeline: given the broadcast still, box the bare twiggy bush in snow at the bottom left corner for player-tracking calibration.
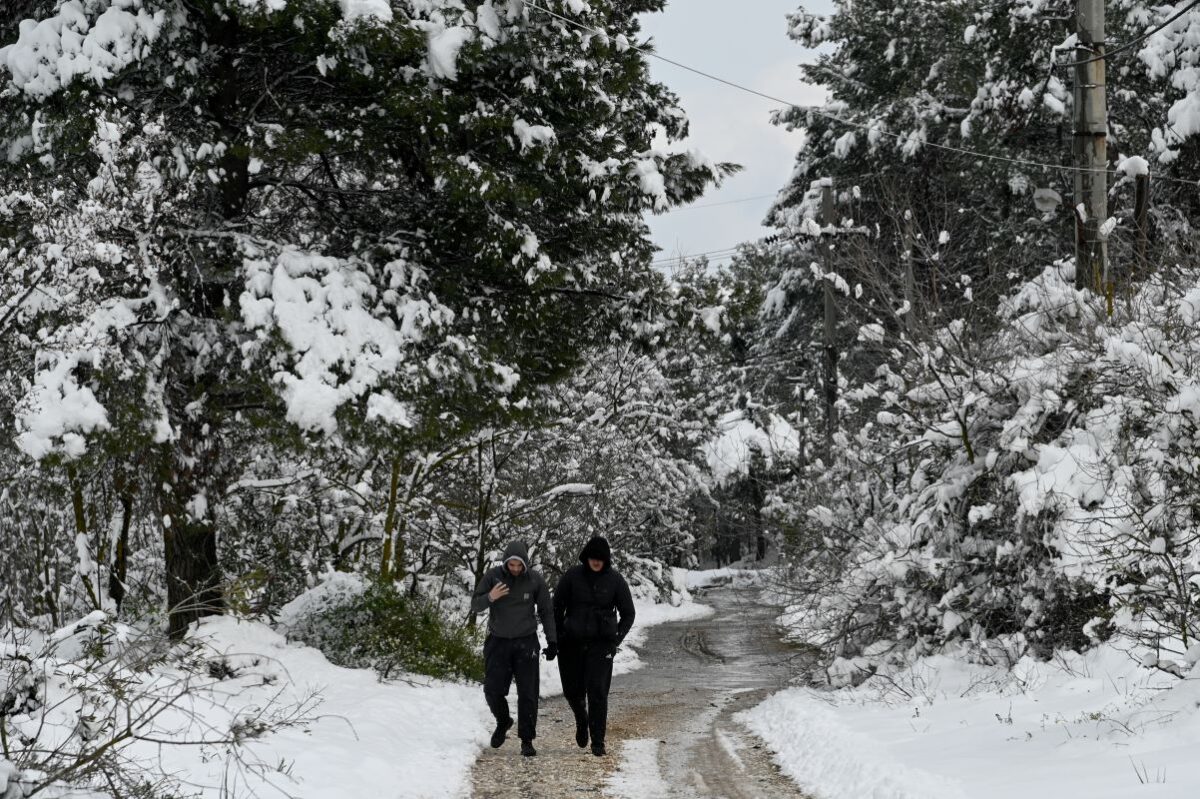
[0,611,312,799]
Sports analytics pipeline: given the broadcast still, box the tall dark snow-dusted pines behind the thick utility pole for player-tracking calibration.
[769,0,1196,323]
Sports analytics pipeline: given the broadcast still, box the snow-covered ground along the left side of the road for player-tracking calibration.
[154,573,710,799]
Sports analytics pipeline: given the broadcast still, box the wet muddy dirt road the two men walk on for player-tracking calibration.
[472,578,803,799]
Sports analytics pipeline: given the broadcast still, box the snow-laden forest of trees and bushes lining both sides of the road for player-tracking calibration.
[0,0,1200,795]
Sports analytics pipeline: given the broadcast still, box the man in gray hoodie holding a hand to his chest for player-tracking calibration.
[470,541,558,757]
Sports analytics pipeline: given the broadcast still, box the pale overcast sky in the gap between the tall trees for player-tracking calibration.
[642,0,833,266]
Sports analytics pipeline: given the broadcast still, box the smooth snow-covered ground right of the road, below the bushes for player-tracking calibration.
[740,645,1200,799]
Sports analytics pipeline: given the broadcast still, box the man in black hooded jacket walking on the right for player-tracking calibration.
[554,535,634,756]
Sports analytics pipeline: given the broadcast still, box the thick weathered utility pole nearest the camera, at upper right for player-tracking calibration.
[1074,0,1112,292]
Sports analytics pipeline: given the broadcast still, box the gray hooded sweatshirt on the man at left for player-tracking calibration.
[470,541,558,643]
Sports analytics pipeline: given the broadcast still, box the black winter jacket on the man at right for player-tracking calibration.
[554,537,635,643]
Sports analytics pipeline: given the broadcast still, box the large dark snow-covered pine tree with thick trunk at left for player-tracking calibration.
[0,0,721,635]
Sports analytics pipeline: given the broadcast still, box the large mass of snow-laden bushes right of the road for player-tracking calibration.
[773,263,1200,678]
